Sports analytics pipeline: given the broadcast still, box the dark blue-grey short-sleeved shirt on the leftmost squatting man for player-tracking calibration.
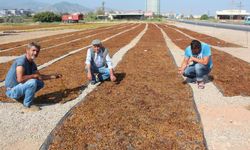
[5,56,37,88]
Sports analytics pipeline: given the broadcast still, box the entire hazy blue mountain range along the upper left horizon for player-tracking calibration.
[0,0,91,13]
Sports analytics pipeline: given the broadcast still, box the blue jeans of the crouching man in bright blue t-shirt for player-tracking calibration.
[183,63,211,81]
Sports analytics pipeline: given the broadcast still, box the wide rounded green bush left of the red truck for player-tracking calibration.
[33,12,61,22]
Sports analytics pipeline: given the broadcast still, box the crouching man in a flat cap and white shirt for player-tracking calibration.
[85,39,116,84]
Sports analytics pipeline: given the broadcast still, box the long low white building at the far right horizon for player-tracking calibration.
[216,9,250,20]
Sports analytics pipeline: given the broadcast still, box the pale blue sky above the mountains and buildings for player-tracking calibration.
[37,0,250,15]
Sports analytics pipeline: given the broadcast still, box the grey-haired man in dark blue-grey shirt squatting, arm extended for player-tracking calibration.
[5,42,61,111]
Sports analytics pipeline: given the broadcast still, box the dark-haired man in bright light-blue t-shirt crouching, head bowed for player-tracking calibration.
[179,40,213,89]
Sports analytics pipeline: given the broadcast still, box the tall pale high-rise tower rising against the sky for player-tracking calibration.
[146,0,160,15]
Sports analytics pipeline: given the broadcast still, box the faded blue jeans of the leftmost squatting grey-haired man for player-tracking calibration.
[6,79,44,107]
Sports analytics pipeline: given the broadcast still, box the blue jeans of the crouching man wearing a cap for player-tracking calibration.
[86,66,110,81]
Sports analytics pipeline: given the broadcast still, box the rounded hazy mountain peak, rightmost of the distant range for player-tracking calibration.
[40,2,91,13]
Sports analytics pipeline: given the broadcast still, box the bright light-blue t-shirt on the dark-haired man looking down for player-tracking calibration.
[185,43,213,69]
